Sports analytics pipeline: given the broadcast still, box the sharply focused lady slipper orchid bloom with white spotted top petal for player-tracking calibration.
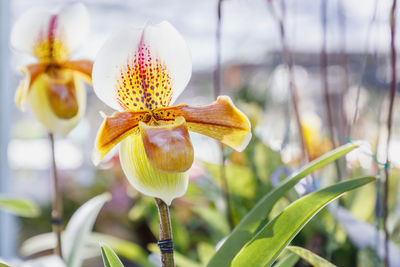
[93,22,251,205]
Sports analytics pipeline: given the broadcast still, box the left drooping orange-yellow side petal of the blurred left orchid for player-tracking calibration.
[14,63,48,110]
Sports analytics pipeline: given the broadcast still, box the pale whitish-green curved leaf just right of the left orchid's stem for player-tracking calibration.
[63,193,111,267]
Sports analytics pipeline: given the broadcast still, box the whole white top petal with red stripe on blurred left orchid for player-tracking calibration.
[11,4,89,61]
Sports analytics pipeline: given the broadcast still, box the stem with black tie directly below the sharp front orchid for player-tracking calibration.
[155,198,175,267]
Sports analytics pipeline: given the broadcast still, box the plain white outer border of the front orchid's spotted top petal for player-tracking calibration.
[92,22,192,110]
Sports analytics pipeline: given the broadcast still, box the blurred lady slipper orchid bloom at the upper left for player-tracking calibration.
[11,4,93,135]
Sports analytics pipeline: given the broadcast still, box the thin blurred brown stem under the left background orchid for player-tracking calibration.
[49,133,63,258]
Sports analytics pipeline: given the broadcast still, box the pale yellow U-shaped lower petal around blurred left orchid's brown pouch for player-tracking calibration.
[28,70,86,136]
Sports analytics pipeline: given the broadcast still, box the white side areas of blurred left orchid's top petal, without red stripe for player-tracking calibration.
[11,3,89,54]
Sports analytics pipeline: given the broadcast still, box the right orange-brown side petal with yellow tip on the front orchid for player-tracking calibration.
[153,96,251,151]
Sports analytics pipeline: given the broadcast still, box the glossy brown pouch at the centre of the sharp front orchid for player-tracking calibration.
[140,117,194,173]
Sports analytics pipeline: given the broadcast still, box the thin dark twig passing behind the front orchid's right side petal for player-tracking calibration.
[214,0,234,229]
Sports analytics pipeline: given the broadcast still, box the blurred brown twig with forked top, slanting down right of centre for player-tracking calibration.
[267,0,308,162]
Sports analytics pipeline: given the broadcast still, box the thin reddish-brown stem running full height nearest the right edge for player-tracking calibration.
[383,0,397,267]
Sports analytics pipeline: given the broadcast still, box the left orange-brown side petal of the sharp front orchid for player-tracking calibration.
[92,111,151,165]
